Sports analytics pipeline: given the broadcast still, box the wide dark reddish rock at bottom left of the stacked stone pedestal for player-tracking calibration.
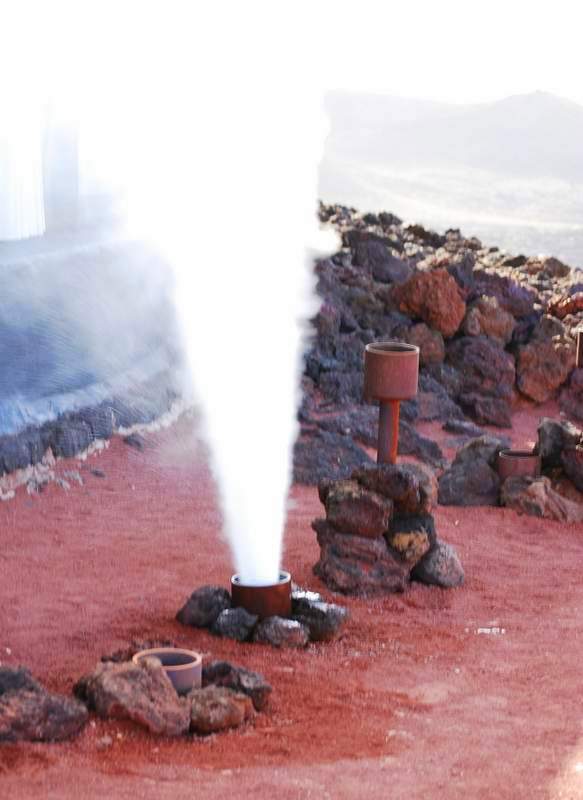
[312,519,409,595]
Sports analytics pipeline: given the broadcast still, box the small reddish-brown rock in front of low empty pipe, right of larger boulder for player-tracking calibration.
[187,686,253,734]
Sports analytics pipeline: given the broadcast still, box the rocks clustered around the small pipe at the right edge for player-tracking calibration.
[438,418,583,522]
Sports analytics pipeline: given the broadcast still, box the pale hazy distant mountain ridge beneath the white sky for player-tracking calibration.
[326,91,583,182]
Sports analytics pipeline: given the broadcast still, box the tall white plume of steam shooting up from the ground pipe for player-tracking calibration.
[118,10,335,585]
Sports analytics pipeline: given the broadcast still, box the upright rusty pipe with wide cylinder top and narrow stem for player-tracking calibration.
[364,342,419,464]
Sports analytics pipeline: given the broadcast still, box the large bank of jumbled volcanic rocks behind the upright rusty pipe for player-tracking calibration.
[294,205,583,484]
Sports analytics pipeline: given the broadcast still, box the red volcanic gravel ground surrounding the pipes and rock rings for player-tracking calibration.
[0,406,583,800]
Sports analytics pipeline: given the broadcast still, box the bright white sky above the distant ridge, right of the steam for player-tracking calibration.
[328,0,583,103]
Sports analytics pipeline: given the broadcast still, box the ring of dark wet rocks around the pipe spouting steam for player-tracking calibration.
[176,586,348,648]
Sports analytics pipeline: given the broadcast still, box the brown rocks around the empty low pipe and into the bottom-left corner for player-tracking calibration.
[0,658,272,743]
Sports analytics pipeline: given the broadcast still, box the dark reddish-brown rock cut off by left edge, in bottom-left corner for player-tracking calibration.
[0,688,88,742]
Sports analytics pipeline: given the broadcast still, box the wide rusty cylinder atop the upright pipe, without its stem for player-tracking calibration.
[364,342,419,401]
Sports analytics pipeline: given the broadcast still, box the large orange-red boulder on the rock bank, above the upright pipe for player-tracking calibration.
[391,269,466,337]
